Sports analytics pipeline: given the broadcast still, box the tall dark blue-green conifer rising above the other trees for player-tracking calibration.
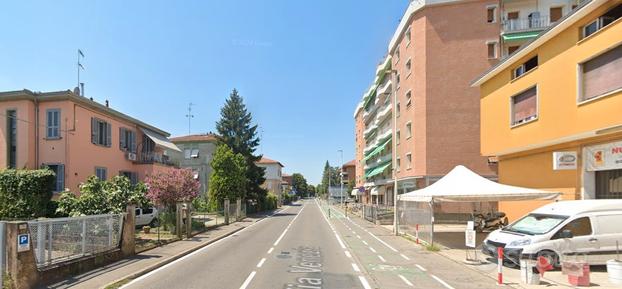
[216,89,267,202]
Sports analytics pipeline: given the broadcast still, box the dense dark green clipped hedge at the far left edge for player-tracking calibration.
[0,169,56,219]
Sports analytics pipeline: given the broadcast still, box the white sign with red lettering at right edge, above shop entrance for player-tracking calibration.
[585,141,622,171]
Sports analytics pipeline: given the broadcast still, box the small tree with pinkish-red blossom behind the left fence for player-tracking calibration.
[146,168,200,209]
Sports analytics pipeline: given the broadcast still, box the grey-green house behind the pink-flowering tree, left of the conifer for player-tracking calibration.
[170,134,217,196]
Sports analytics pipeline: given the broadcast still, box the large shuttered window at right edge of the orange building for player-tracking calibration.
[579,45,622,102]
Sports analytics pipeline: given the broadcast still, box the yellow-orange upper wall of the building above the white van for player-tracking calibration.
[480,0,622,156]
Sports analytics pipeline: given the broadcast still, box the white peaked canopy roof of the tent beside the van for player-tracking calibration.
[398,165,561,202]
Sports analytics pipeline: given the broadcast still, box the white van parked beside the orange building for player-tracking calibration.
[482,199,622,266]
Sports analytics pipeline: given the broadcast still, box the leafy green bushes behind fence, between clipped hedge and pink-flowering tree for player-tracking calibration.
[56,176,149,216]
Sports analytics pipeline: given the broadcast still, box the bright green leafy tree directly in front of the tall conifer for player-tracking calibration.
[209,144,247,209]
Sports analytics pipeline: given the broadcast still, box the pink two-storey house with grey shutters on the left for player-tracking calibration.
[0,90,179,193]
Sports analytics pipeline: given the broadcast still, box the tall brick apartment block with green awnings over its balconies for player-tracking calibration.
[357,1,500,205]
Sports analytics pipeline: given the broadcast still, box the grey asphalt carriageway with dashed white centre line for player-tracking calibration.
[124,201,370,289]
